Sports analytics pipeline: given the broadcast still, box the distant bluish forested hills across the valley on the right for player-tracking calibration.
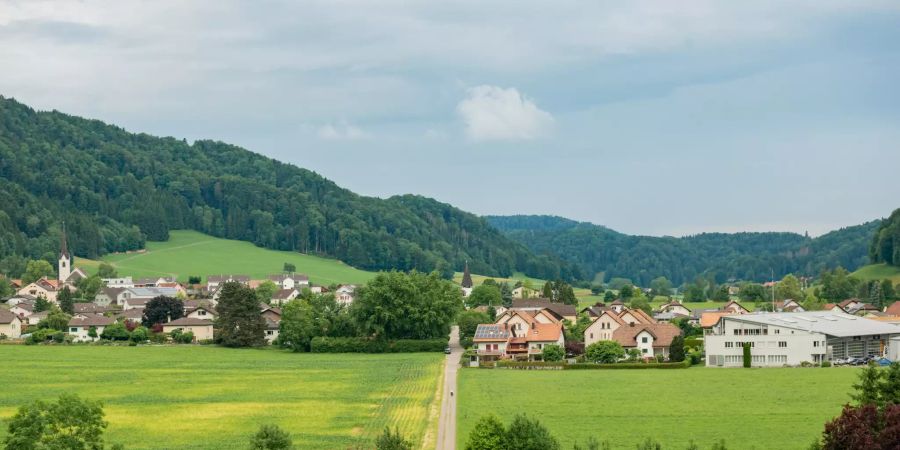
[486,216,881,286]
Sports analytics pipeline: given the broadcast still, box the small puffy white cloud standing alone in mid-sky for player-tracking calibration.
[456,85,553,141]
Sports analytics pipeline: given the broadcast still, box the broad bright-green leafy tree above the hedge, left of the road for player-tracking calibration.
[350,270,463,339]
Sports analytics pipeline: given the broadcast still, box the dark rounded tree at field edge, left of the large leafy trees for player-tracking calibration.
[216,281,266,347]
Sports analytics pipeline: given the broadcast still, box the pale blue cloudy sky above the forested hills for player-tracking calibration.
[0,0,900,236]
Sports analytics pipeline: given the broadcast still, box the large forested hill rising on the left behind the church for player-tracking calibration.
[0,97,577,279]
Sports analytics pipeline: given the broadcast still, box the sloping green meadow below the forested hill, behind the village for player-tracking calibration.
[97,230,375,285]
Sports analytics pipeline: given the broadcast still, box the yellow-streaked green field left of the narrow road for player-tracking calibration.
[0,345,444,449]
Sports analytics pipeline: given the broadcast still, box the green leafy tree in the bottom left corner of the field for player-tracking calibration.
[4,394,107,450]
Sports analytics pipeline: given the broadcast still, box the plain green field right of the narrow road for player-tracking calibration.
[457,367,859,450]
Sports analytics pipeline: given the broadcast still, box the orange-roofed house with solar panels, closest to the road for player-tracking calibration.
[472,321,565,364]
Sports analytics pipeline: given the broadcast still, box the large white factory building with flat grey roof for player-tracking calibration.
[704,311,900,367]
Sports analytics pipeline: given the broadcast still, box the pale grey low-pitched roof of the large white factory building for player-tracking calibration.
[721,311,900,337]
